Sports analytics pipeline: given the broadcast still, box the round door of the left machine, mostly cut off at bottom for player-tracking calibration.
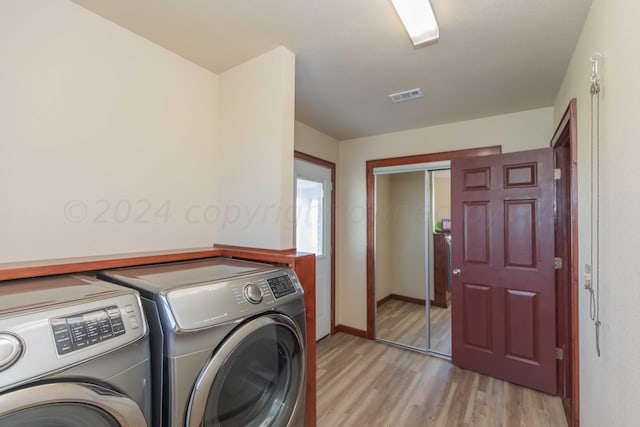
[0,382,147,427]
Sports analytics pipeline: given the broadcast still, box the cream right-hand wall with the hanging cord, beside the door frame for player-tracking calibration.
[554,0,640,427]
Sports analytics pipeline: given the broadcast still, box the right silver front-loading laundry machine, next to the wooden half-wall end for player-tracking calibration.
[98,258,306,427]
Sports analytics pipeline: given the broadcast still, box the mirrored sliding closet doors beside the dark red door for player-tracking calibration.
[374,162,451,357]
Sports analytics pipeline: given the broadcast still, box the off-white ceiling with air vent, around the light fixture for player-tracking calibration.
[73,0,591,140]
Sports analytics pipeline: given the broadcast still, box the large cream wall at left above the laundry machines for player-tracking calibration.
[0,0,218,262]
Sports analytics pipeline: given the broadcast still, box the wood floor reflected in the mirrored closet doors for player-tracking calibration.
[376,299,451,354]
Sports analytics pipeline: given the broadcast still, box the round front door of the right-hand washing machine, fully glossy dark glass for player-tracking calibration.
[186,314,306,427]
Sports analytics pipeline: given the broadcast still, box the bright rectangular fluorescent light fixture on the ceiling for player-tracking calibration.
[391,0,440,46]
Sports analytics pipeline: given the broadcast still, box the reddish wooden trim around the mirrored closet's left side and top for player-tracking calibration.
[366,145,502,340]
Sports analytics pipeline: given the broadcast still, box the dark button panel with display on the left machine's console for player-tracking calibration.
[49,305,132,356]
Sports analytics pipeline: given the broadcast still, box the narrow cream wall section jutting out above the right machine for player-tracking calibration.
[216,47,295,249]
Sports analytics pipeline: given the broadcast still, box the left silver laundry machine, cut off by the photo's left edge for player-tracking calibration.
[0,275,151,427]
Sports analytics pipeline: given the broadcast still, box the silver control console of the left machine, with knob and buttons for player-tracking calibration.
[0,288,148,394]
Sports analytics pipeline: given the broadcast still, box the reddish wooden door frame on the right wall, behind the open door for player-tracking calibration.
[551,98,580,426]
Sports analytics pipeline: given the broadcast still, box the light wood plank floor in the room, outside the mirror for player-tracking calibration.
[317,333,567,427]
